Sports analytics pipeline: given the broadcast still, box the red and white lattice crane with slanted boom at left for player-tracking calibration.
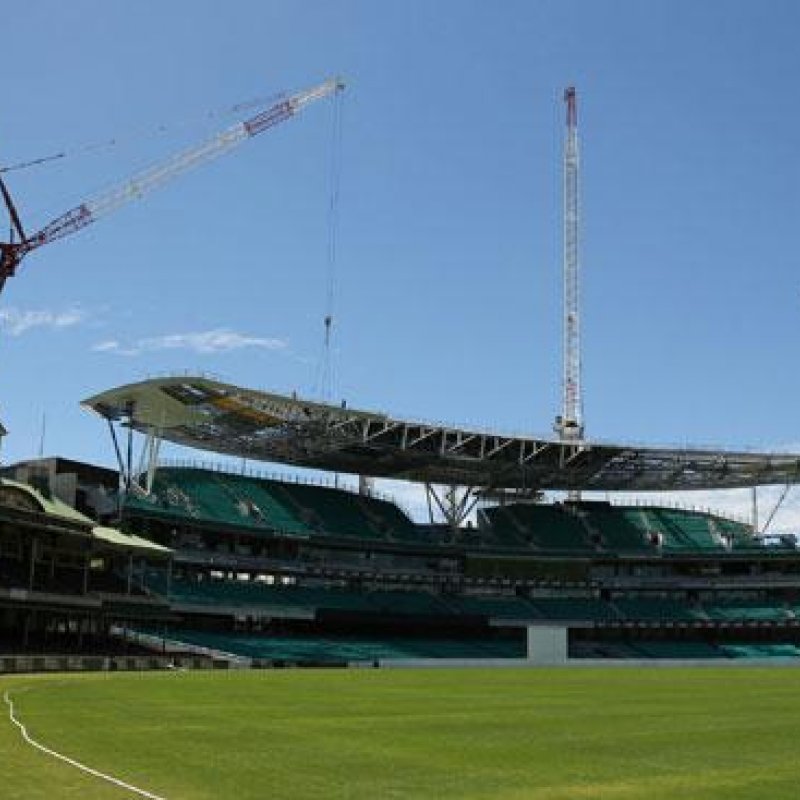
[0,78,344,291]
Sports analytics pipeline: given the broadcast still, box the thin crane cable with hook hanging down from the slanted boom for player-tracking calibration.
[317,85,344,402]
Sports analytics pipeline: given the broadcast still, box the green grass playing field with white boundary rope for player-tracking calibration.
[0,669,800,800]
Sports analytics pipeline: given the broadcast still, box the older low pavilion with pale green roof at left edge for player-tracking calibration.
[0,478,171,653]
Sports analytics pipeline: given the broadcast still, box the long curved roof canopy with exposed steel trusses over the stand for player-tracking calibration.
[82,377,800,491]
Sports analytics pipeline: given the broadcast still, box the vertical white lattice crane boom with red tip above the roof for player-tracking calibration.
[554,86,583,441]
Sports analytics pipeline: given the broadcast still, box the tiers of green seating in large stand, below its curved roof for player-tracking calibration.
[4,466,788,664]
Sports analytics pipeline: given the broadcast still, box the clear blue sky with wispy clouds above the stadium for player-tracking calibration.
[0,0,800,527]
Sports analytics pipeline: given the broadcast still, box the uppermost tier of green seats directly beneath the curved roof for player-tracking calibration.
[125,467,763,556]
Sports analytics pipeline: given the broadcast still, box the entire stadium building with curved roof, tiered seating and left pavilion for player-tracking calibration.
[0,378,800,665]
